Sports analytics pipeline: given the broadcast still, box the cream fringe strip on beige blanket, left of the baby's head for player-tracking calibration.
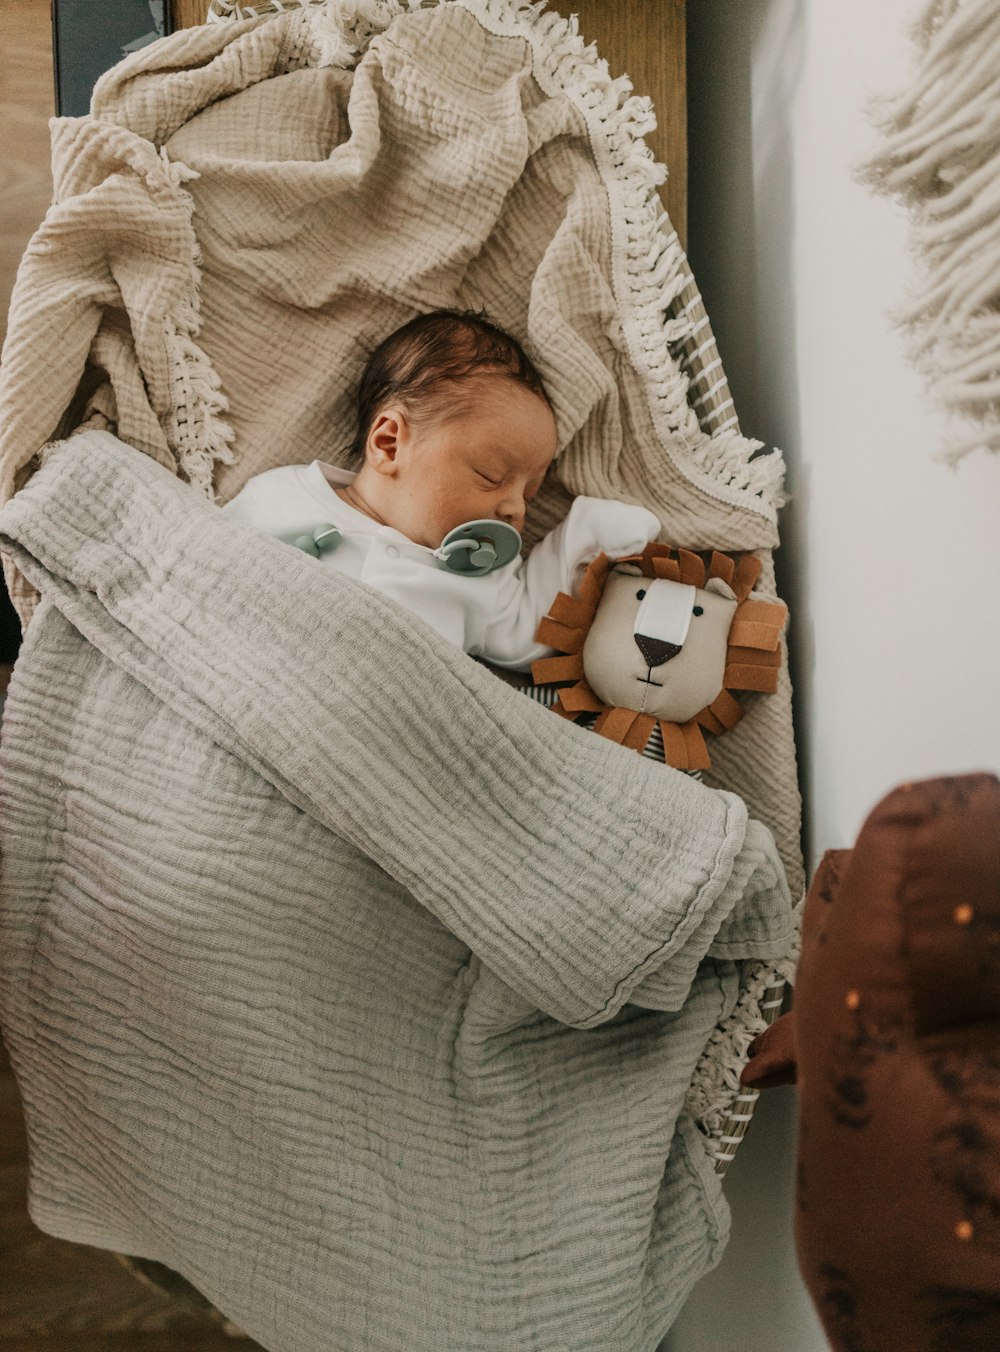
[159,150,234,502]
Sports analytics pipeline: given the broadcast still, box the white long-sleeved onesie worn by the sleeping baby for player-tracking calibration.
[223,460,659,669]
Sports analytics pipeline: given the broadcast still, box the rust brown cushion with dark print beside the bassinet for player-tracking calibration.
[795,775,1000,1352]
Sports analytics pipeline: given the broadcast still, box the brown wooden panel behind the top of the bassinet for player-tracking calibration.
[170,0,688,243]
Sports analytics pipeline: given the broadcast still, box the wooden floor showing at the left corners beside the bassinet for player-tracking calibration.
[0,0,257,1352]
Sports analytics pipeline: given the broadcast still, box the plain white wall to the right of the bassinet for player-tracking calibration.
[665,0,1000,1352]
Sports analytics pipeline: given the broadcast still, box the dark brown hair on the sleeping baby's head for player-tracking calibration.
[350,310,549,460]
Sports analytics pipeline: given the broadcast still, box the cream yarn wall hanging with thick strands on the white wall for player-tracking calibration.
[858,0,1000,464]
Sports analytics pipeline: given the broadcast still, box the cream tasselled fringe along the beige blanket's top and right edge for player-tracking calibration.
[208,0,785,522]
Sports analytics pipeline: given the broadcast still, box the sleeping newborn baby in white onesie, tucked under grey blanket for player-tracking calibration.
[223,310,659,669]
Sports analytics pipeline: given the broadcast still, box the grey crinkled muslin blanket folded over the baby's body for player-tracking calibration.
[0,431,792,1352]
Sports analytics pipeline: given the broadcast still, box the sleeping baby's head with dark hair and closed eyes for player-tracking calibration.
[353,310,555,549]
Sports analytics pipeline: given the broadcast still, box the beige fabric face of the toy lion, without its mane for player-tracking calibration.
[582,566,736,723]
